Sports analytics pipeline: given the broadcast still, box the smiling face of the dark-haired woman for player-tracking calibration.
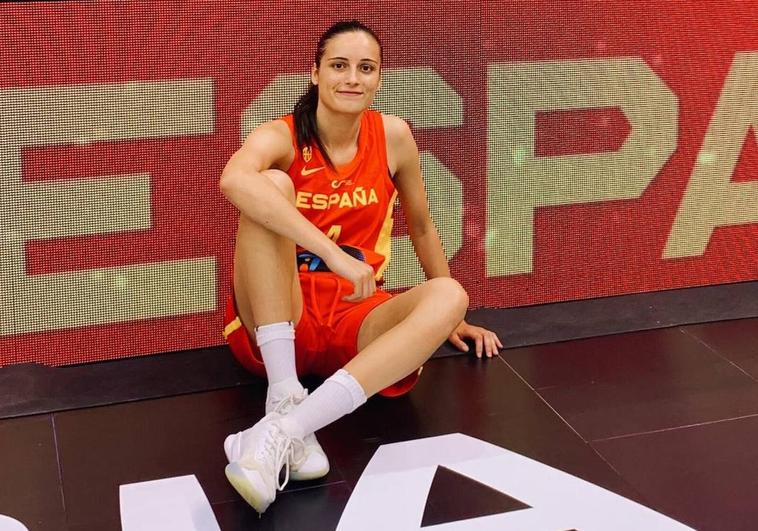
[311,31,381,114]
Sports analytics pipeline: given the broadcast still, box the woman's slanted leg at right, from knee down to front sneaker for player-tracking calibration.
[226,278,468,512]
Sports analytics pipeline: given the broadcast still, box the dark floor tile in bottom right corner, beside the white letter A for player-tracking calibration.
[593,416,758,531]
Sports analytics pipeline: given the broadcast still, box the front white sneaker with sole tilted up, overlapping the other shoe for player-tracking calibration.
[224,413,305,513]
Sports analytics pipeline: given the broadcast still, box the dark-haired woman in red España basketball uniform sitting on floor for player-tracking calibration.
[220,21,502,513]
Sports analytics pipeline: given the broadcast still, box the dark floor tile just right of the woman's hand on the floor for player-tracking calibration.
[505,323,758,440]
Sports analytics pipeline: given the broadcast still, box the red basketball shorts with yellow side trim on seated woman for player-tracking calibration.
[224,272,421,397]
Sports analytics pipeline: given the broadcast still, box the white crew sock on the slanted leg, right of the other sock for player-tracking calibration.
[279,369,366,439]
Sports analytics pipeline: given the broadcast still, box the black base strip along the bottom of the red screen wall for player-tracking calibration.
[0,282,758,418]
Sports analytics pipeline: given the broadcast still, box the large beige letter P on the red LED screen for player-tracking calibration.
[487,58,677,276]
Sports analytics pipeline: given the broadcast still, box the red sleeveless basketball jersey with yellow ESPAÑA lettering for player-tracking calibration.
[282,110,397,280]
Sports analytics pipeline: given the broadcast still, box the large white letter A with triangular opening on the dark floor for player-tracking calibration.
[337,433,691,531]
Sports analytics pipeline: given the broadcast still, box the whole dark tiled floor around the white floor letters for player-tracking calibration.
[0,319,758,531]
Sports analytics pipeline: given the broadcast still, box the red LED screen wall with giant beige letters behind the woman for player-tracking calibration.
[0,0,758,364]
